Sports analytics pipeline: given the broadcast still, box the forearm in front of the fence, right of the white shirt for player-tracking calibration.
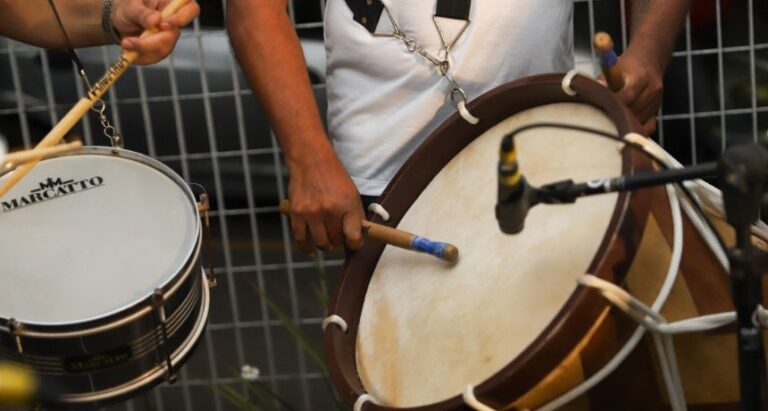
[628,0,690,72]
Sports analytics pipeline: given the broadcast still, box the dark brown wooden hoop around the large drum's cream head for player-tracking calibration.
[325,74,642,411]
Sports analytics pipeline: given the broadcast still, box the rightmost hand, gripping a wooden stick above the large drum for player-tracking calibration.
[598,49,664,136]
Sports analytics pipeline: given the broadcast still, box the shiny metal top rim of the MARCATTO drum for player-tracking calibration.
[0,146,202,332]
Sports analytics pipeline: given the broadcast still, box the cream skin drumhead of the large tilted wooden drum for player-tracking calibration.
[357,103,622,407]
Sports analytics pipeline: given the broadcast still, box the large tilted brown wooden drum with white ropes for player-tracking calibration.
[325,75,768,411]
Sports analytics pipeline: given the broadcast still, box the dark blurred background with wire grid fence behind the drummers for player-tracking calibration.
[0,0,768,411]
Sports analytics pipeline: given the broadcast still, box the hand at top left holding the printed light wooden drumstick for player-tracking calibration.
[112,0,200,64]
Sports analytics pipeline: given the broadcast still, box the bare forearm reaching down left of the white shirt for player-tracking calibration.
[227,0,333,171]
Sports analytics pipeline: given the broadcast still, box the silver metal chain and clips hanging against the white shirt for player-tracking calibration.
[374,5,470,115]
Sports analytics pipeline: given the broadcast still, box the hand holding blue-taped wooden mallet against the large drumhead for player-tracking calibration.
[288,153,365,253]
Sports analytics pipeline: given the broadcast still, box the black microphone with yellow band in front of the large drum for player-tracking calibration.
[496,134,538,234]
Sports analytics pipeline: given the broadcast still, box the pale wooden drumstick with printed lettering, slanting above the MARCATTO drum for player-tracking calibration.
[0,0,189,197]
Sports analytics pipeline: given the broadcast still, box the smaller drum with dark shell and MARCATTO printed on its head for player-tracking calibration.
[0,147,209,406]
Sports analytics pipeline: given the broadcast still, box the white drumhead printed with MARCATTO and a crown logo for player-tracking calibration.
[0,149,198,324]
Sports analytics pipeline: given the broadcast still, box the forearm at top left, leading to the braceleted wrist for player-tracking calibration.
[0,0,114,48]
